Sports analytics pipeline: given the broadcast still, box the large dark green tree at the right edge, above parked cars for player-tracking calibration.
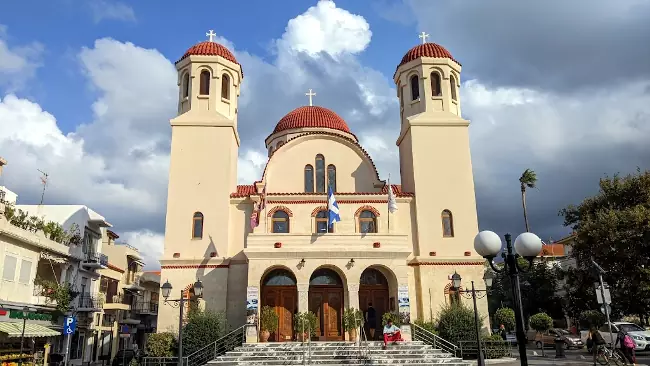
[560,169,650,318]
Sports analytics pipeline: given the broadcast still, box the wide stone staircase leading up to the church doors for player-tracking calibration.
[208,341,470,366]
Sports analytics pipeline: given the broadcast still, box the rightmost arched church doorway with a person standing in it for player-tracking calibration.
[359,268,390,340]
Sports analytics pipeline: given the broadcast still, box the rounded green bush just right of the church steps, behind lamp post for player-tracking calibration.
[436,303,484,344]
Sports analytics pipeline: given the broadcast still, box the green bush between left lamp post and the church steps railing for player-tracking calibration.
[183,310,226,355]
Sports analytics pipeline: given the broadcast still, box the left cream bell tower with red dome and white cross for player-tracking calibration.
[158,30,243,329]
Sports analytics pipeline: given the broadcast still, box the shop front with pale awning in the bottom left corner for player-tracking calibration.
[0,307,61,366]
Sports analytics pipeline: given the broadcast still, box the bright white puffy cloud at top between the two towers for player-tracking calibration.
[278,0,372,57]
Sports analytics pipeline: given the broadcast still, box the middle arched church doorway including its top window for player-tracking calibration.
[309,268,343,341]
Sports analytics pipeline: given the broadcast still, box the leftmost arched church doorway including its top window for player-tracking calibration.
[262,268,298,342]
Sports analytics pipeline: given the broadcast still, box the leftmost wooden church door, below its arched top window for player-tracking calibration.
[262,286,297,342]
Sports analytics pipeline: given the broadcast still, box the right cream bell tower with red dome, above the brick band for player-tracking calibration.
[394,32,478,258]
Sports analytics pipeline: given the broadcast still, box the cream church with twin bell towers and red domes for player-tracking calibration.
[158,32,487,342]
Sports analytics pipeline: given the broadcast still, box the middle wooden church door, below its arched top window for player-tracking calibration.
[309,287,343,341]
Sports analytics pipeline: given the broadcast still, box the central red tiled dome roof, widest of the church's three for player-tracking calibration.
[273,106,351,133]
